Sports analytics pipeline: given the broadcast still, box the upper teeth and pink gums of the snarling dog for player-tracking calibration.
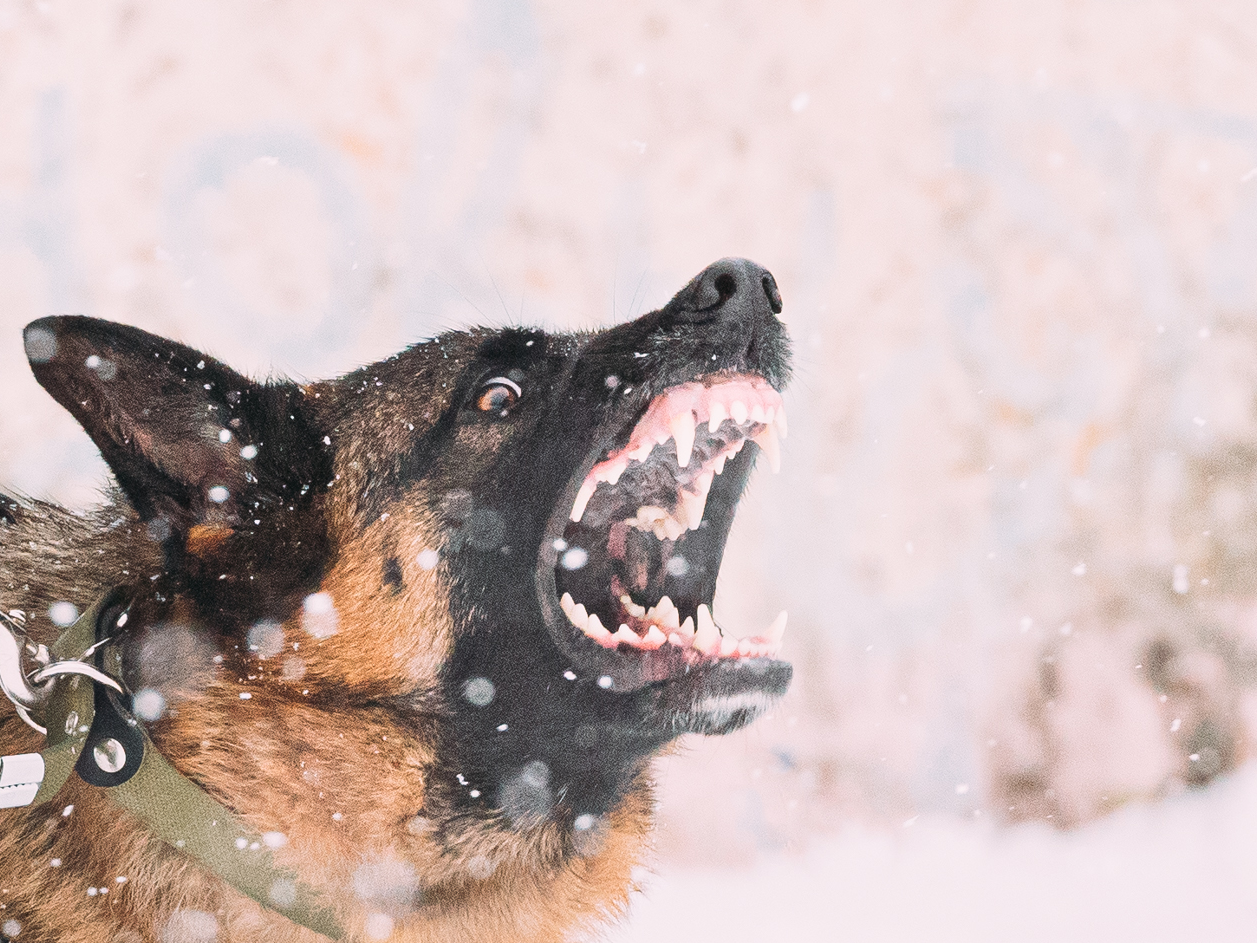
[571,377,787,525]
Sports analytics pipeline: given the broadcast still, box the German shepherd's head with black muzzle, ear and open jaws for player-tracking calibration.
[25,260,791,870]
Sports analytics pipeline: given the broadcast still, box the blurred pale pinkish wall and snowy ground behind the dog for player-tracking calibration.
[0,0,1257,943]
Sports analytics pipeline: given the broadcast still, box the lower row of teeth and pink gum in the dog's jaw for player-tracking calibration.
[559,592,786,658]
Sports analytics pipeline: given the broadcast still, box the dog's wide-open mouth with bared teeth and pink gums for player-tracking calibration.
[547,373,786,680]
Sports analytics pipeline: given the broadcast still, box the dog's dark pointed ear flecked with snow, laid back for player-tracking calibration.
[25,317,331,537]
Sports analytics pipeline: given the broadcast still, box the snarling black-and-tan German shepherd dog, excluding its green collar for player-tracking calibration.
[0,259,791,943]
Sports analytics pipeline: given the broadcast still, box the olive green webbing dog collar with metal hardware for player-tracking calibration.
[0,587,343,940]
